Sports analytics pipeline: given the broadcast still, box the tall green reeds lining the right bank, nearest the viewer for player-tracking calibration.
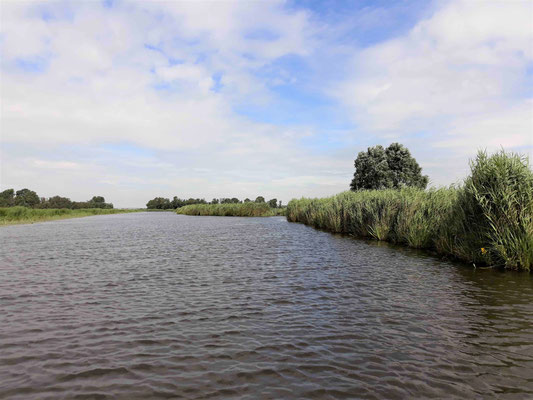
[287,150,533,271]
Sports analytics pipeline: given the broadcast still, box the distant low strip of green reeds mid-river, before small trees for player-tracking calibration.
[176,202,285,217]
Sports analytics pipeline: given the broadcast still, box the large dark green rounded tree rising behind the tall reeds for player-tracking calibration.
[350,143,429,191]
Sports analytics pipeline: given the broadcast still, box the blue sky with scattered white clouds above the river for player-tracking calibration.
[0,0,533,207]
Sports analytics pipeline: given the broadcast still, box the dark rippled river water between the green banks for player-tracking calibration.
[0,213,533,399]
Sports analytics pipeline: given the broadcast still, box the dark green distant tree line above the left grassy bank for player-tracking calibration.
[0,189,113,210]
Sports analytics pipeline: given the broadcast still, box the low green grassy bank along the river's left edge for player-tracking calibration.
[0,207,145,225]
